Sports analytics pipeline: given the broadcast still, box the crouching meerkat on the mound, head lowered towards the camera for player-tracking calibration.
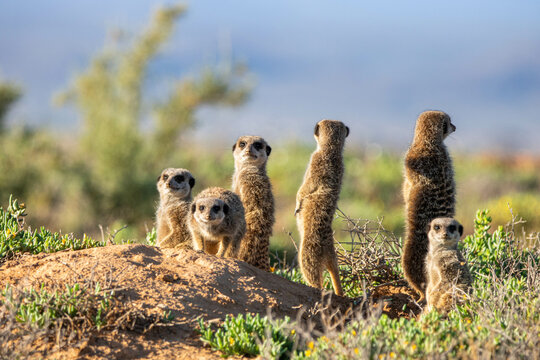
[188,187,246,258]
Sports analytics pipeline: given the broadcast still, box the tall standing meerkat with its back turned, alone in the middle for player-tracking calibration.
[294,120,349,296]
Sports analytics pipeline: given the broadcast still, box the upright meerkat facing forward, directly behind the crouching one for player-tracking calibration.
[232,136,275,271]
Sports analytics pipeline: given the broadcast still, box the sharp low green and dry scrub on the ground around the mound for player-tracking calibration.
[0,195,540,359]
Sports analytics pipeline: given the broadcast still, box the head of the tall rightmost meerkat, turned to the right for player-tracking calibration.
[414,111,456,142]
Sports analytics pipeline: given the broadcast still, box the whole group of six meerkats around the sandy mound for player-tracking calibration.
[156,111,471,311]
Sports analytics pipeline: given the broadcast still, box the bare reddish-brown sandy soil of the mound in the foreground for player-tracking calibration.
[0,245,419,359]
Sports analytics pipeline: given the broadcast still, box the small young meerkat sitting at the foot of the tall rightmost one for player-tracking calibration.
[426,218,472,312]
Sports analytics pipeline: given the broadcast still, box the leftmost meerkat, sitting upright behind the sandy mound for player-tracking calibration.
[156,168,195,248]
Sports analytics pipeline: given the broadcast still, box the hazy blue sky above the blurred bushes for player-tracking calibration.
[0,0,540,154]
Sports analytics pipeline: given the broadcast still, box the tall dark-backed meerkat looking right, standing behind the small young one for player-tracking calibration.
[401,111,456,301]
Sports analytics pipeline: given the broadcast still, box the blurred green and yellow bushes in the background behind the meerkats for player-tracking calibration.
[0,6,540,255]
